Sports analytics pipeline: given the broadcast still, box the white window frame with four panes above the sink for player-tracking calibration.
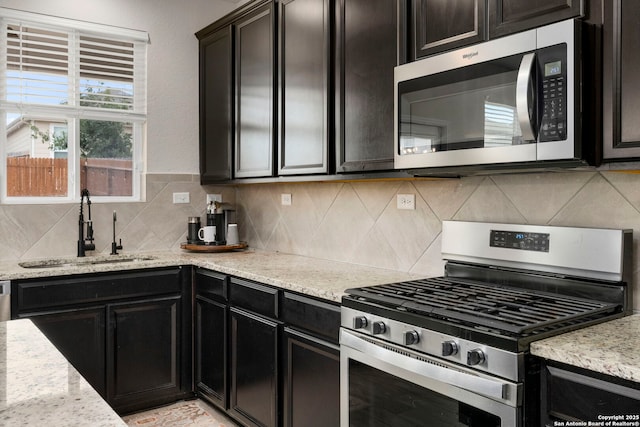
[0,7,149,204]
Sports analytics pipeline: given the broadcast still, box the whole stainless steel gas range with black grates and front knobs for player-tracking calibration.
[340,221,632,427]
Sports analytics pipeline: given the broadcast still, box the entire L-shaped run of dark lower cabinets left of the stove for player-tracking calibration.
[17,267,340,427]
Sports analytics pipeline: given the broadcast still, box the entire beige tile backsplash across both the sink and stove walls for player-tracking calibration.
[0,171,640,311]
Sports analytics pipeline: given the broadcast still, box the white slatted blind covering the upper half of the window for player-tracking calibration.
[0,8,148,114]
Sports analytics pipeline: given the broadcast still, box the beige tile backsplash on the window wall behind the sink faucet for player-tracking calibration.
[0,175,235,261]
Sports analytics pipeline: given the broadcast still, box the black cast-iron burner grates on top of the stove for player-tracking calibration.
[347,277,618,335]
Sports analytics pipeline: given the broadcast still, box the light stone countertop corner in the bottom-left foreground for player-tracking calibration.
[0,319,126,427]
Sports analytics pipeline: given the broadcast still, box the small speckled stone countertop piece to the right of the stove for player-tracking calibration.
[531,314,640,382]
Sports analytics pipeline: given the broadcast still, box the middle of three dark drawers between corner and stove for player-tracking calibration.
[229,277,280,319]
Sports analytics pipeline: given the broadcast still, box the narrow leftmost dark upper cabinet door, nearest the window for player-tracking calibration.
[200,27,233,184]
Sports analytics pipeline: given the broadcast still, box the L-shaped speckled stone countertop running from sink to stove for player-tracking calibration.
[0,249,421,302]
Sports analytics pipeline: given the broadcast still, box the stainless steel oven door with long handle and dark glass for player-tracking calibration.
[340,328,523,427]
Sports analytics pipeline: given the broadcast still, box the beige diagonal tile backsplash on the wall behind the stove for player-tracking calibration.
[236,171,640,310]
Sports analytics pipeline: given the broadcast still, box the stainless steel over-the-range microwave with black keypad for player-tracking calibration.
[394,20,597,175]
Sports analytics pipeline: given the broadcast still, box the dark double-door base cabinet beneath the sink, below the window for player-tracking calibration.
[12,267,193,414]
